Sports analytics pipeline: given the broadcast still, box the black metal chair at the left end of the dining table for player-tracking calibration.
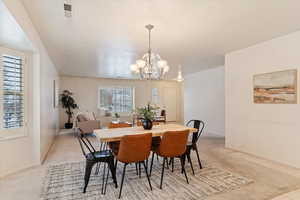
[77,129,118,194]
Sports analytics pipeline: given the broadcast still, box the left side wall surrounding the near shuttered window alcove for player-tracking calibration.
[0,0,59,177]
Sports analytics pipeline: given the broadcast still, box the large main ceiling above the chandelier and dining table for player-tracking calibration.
[22,0,300,78]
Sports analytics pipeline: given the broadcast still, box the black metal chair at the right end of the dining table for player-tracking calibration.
[184,119,205,174]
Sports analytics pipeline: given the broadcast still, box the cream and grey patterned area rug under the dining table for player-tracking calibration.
[41,160,253,200]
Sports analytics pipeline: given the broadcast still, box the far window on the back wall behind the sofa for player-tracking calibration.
[99,87,134,113]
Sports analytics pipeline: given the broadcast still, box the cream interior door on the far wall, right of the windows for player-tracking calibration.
[163,87,177,122]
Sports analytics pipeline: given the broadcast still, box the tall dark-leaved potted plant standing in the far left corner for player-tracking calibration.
[60,90,79,129]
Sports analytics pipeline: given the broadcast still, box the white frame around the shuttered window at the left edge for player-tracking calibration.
[0,46,28,140]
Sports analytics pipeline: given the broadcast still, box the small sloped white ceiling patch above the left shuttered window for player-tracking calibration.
[0,0,34,51]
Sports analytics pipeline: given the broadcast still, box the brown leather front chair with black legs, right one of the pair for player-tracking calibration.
[150,130,189,189]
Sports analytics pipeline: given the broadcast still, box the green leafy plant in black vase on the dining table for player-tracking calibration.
[136,103,159,130]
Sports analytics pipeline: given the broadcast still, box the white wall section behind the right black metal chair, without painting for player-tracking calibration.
[184,66,225,136]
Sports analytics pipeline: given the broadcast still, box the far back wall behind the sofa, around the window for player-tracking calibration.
[60,76,182,127]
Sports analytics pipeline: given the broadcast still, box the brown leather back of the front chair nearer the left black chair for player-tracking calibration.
[117,133,152,163]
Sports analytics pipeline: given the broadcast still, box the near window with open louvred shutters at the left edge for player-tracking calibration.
[0,49,25,137]
